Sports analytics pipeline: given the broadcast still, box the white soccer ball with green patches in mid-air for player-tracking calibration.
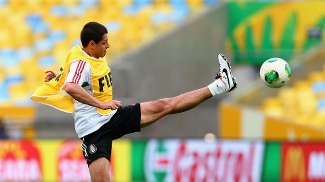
[260,58,291,88]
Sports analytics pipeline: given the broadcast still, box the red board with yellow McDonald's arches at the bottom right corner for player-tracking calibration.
[281,142,325,182]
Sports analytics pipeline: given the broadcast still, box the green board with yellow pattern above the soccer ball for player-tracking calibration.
[226,1,325,65]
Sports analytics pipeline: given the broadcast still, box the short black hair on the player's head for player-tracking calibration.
[80,22,108,47]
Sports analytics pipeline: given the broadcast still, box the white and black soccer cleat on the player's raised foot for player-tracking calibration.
[216,54,237,92]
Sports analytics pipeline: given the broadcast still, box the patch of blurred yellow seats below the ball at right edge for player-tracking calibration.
[262,63,325,127]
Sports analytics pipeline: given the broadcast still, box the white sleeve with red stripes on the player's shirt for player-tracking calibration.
[65,60,91,85]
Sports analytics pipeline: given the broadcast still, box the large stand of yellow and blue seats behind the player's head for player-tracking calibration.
[0,0,218,137]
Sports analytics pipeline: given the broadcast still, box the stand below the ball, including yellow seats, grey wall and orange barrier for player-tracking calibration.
[221,44,325,140]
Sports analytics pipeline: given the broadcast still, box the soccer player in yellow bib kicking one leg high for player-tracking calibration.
[32,22,237,182]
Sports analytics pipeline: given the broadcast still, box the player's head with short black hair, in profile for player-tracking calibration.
[80,22,109,58]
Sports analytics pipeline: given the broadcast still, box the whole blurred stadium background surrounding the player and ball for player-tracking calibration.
[0,0,325,182]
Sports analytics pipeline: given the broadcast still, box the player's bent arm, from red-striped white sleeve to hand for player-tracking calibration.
[65,60,122,110]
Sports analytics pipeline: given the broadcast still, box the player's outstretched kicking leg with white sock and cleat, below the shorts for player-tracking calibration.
[140,54,237,127]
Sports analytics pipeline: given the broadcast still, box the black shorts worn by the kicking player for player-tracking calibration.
[81,103,141,166]
